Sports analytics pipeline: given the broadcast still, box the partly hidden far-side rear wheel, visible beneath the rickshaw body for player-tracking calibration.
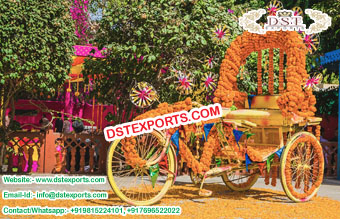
[222,170,260,192]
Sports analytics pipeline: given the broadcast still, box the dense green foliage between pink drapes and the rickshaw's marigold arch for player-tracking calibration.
[83,0,242,120]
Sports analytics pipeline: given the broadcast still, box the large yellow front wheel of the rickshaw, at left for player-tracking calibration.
[107,132,176,205]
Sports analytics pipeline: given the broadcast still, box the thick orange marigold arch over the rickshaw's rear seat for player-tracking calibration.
[214,31,316,117]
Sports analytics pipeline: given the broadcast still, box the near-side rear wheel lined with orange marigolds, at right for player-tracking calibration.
[280,132,324,202]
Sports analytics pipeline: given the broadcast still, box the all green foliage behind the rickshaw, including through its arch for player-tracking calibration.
[84,0,340,125]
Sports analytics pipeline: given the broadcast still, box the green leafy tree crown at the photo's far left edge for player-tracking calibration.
[0,0,75,92]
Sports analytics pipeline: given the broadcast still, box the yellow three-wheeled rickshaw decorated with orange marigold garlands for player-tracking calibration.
[107,31,324,205]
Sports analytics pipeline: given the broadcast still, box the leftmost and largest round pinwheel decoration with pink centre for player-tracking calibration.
[130,82,158,108]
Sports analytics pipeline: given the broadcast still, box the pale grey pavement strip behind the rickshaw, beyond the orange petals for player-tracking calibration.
[0,174,340,201]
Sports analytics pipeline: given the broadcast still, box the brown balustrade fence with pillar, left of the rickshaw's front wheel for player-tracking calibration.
[0,130,109,174]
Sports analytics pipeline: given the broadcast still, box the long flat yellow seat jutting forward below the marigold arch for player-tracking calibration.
[224,109,285,127]
